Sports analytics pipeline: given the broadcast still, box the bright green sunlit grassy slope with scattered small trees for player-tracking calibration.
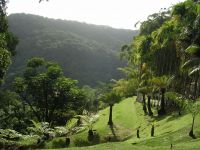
[43,98,200,150]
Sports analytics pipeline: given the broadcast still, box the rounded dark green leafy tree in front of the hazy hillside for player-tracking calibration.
[13,58,85,125]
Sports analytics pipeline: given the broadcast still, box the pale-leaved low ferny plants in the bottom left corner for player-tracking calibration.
[0,120,69,149]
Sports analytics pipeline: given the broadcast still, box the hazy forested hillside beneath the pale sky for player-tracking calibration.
[8,14,136,86]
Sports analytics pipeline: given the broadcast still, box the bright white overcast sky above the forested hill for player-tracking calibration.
[7,0,184,29]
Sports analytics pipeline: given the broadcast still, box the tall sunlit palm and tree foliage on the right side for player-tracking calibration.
[122,0,200,104]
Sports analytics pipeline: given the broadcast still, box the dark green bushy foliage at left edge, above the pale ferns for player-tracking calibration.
[0,90,31,131]
